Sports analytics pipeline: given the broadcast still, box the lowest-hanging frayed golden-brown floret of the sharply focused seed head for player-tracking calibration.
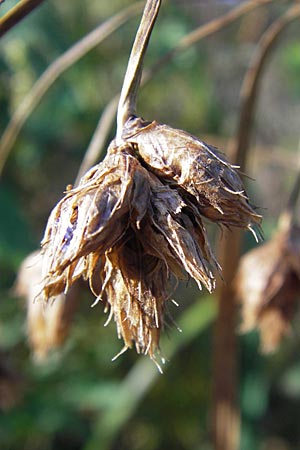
[98,237,167,358]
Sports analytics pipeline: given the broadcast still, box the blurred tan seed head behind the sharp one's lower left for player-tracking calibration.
[15,252,75,361]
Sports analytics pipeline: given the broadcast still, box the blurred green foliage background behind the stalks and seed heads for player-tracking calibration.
[0,0,300,450]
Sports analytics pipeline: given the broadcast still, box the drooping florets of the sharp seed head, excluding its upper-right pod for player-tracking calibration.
[42,143,219,358]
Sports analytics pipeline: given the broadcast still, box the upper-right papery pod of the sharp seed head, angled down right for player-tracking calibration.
[123,117,261,236]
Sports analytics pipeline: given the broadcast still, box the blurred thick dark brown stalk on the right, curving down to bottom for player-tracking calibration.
[213,3,300,450]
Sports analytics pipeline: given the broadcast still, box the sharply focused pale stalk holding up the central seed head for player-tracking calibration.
[116,0,161,143]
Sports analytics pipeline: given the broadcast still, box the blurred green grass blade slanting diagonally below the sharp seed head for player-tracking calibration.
[84,296,216,450]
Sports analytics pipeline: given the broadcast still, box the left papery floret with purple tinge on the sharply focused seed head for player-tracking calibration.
[42,146,147,284]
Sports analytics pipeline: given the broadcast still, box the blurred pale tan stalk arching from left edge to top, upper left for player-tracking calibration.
[0,2,143,175]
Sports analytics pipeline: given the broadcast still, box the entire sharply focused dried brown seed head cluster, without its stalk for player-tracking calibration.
[42,117,261,358]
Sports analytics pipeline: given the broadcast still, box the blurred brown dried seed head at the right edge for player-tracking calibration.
[235,224,300,353]
